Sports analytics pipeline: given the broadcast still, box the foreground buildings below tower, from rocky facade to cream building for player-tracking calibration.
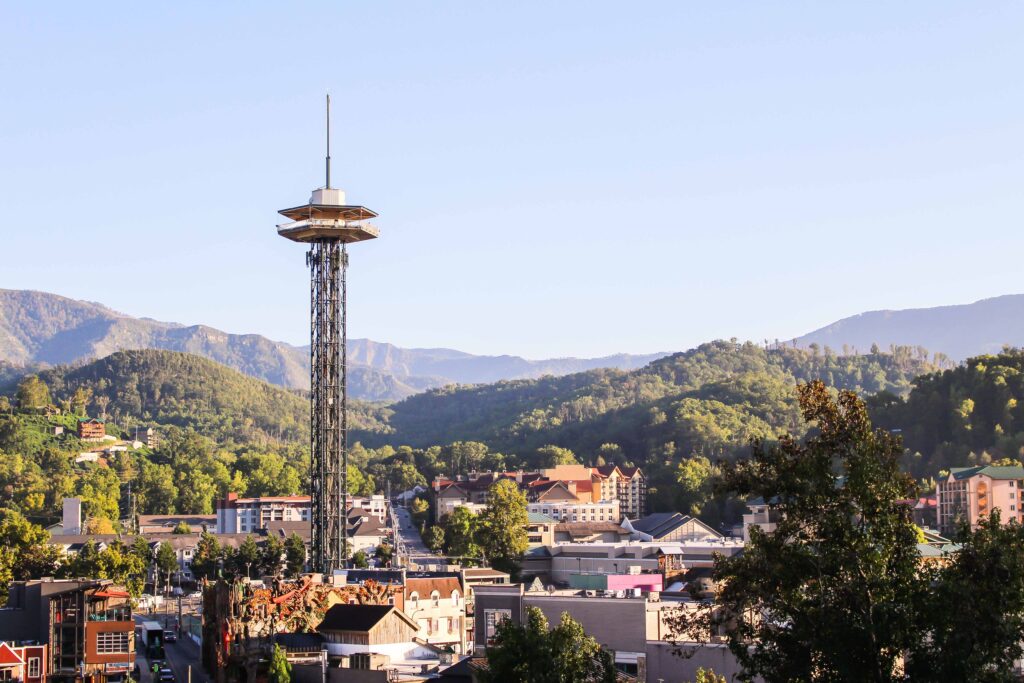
[203,567,509,683]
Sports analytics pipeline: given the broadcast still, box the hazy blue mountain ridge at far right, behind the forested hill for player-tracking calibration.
[793,294,1024,361]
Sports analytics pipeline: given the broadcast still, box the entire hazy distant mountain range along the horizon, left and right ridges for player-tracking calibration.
[8,290,1024,400]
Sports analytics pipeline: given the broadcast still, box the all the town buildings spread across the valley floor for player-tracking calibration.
[8,466,1024,683]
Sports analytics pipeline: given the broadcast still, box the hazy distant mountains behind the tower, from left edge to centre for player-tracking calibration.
[0,290,666,400]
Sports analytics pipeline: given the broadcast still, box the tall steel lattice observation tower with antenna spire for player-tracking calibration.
[278,96,379,574]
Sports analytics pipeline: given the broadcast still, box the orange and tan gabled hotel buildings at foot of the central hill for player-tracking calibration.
[433,465,647,523]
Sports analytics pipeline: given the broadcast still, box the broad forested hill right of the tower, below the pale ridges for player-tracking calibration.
[378,341,934,457]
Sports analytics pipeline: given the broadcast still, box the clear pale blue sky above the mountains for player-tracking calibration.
[0,1,1024,357]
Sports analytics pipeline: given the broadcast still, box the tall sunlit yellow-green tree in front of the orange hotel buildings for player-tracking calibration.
[480,479,529,573]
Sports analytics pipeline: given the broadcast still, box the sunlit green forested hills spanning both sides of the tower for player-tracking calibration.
[0,341,962,523]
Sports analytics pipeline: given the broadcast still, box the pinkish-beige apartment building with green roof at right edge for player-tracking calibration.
[935,465,1024,533]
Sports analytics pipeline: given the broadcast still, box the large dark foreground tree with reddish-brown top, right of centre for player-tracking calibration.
[675,382,922,683]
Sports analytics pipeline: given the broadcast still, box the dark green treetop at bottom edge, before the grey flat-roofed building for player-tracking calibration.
[479,607,616,683]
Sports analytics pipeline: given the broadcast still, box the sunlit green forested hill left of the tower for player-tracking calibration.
[0,350,387,529]
